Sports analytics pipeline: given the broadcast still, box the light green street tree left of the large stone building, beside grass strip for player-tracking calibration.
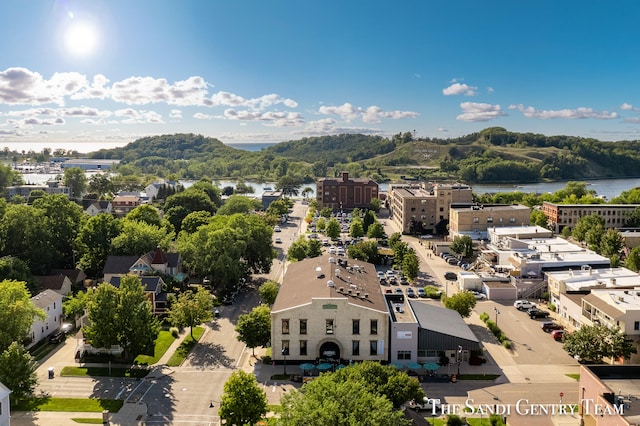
[169,287,213,339]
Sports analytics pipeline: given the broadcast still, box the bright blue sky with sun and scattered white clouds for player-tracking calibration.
[0,0,640,152]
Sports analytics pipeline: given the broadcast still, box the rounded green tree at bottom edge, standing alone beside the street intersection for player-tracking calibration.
[218,370,267,425]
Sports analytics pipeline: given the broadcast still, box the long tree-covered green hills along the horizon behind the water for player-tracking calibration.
[84,127,640,183]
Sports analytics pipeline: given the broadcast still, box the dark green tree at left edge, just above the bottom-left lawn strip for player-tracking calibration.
[0,342,38,402]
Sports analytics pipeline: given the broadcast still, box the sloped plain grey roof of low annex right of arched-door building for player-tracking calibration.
[409,300,479,342]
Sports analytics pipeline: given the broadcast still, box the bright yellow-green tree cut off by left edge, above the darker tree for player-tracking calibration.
[0,280,46,352]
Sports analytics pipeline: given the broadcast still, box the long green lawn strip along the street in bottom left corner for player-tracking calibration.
[13,398,124,413]
